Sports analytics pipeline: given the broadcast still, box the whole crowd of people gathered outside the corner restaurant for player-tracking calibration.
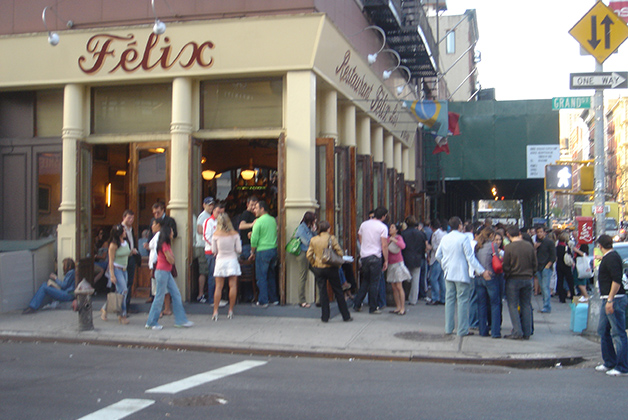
[17,196,628,375]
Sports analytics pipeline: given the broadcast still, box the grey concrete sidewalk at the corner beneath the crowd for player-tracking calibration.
[0,296,601,367]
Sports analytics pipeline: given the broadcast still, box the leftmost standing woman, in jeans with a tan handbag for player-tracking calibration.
[100,225,131,325]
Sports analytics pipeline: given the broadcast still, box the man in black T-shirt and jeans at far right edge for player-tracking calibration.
[595,235,628,376]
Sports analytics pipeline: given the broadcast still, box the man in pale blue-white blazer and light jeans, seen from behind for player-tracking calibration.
[436,216,491,336]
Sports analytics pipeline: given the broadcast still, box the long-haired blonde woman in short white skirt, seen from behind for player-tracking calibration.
[212,213,242,321]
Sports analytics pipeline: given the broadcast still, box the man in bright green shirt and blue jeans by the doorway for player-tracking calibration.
[249,201,279,308]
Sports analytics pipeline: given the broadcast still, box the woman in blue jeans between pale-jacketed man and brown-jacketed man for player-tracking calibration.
[474,226,502,338]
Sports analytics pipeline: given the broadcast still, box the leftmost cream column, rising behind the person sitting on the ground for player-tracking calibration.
[57,84,84,272]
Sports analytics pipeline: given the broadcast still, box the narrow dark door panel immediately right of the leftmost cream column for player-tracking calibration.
[75,142,94,285]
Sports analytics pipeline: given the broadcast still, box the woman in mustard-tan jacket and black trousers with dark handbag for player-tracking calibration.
[306,220,353,322]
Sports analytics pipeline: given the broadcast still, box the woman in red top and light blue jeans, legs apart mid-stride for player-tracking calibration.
[145,224,194,330]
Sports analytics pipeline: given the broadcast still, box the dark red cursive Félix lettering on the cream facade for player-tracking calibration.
[78,33,214,75]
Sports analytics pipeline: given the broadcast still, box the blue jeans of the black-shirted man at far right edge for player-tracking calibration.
[597,296,628,373]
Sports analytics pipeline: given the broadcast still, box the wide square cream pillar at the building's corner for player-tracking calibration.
[281,70,318,303]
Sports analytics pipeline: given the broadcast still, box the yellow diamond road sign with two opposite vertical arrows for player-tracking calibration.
[569,1,628,64]
